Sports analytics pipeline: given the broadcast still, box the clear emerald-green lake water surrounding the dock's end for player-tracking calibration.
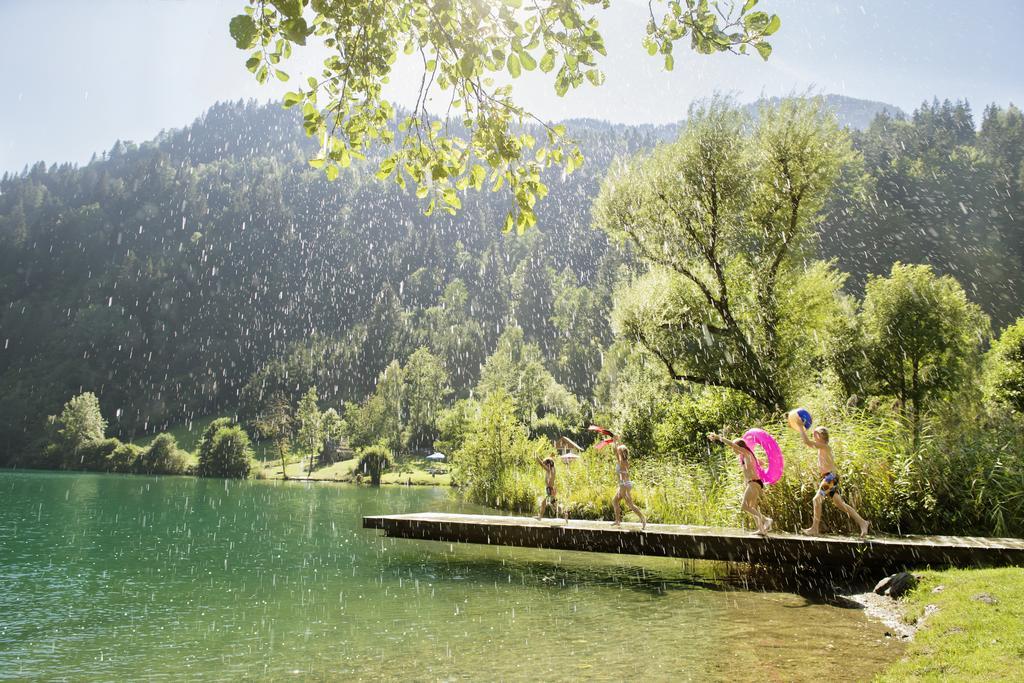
[0,472,900,681]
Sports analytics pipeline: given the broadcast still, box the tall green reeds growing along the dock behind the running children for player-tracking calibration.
[468,402,1024,536]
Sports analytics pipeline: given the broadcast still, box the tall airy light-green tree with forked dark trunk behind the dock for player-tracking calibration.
[594,98,856,409]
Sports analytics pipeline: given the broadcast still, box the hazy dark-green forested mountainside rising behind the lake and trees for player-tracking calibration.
[0,93,1024,461]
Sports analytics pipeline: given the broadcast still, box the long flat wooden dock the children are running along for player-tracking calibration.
[362,512,1024,569]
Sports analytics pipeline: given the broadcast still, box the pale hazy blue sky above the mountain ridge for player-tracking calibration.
[0,0,1024,172]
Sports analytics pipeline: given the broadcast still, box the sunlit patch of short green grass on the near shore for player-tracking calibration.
[877,567,1024,681]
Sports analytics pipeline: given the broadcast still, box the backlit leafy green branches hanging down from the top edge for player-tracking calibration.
[229,0,780,230]
